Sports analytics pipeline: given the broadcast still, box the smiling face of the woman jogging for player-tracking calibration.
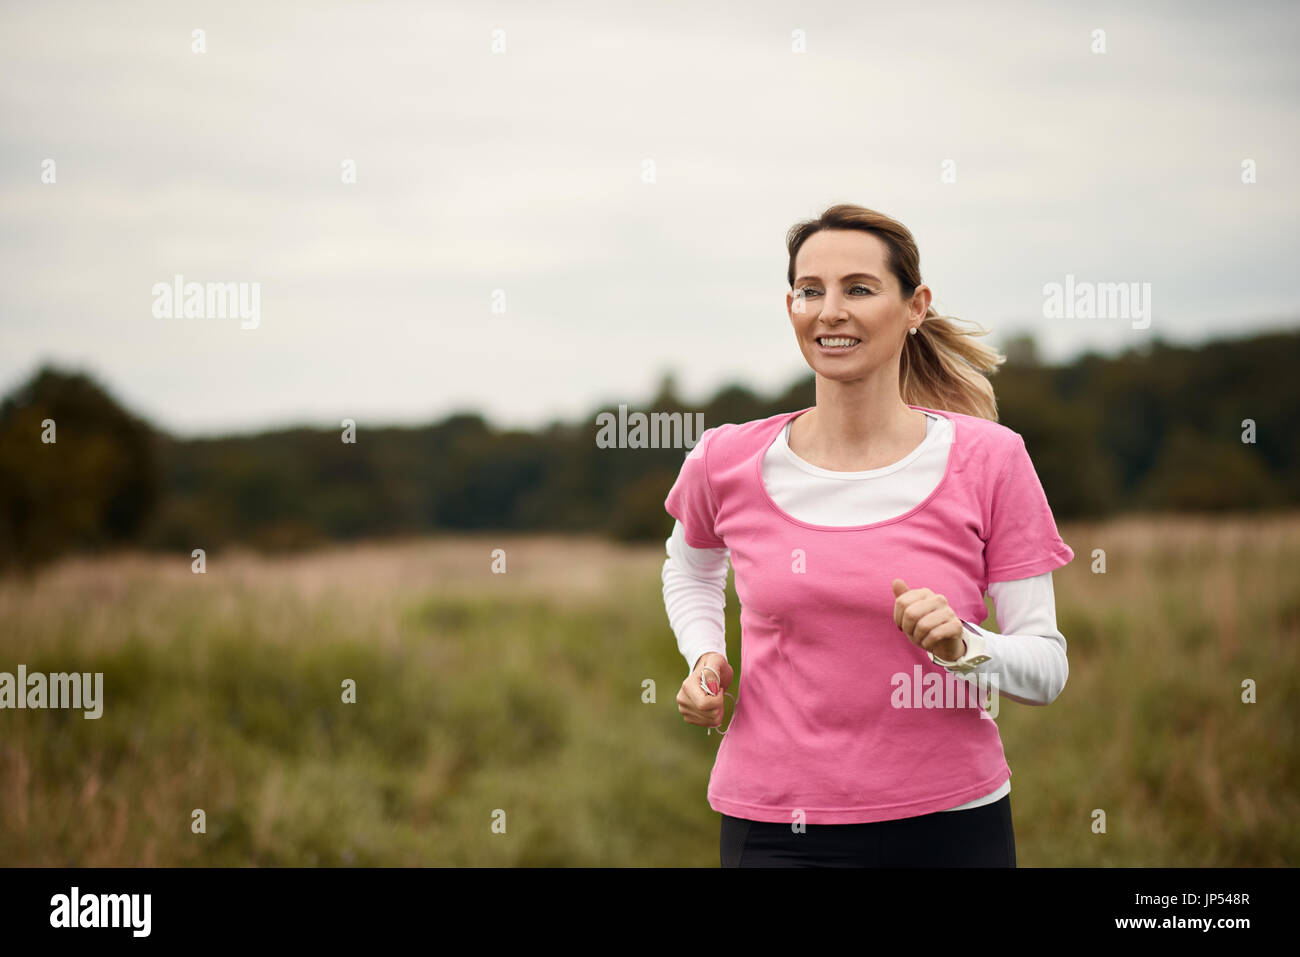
[785,229,930,381]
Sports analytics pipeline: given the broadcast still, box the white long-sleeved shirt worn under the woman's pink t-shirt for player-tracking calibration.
[663,412,1069,810]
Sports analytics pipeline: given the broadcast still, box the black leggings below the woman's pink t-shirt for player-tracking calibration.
[720,794,1015,867]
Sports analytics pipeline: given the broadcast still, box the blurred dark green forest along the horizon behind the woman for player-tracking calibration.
[0,333,1300,567]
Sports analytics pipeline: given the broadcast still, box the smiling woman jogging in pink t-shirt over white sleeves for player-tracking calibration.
[663,204,1074,867]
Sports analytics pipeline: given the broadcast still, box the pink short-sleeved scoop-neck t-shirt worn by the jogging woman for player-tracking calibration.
[664,406,1074,824]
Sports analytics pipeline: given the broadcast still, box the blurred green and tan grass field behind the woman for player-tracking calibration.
[0,515,1300,867]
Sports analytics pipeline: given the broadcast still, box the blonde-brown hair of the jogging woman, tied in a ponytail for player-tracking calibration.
[785,203,1006,421]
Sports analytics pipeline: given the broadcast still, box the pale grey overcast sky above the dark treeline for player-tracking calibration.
[0,0,1300,436]
